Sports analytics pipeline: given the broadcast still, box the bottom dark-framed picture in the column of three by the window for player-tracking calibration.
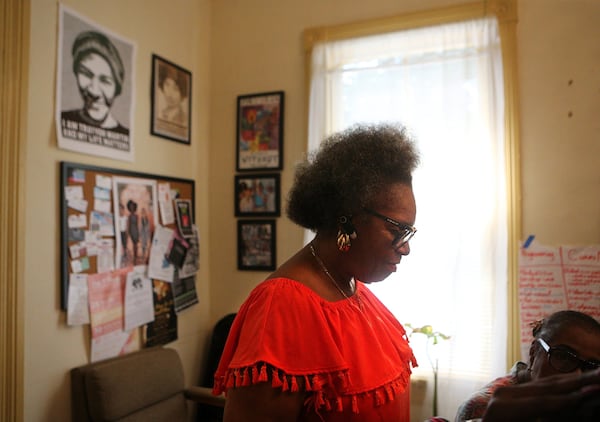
[238,220,277,271]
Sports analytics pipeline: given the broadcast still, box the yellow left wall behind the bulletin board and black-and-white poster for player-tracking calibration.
[24,0,210,422]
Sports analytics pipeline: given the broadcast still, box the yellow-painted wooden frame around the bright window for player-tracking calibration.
[304,0,522,368]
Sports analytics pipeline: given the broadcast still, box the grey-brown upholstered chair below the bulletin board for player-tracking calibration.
[71,346,225,422]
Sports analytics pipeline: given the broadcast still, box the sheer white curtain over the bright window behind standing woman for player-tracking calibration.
[307,18,508,420]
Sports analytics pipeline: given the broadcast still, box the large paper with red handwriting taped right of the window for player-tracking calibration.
[519,242,600,362]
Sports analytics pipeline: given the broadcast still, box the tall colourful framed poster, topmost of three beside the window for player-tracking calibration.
[236,91,284,171]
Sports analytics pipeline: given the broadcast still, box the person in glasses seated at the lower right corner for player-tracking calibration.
[455,310,600,422]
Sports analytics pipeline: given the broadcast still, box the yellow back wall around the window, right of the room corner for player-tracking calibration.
[211,0,600,310]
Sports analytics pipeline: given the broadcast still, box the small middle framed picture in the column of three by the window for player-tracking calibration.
[234,173,280,217]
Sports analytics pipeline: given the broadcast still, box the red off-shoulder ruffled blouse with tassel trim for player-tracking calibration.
[213,278,417,422]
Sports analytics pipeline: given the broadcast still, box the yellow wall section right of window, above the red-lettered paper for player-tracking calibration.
[518,0,600,244]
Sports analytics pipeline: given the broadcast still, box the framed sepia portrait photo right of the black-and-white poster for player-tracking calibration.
[150,54,192,145]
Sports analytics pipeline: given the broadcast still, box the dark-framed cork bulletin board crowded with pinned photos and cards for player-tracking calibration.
[60,162,195,310]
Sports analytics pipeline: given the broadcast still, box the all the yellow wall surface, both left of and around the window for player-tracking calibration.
[24,0,600,422]
